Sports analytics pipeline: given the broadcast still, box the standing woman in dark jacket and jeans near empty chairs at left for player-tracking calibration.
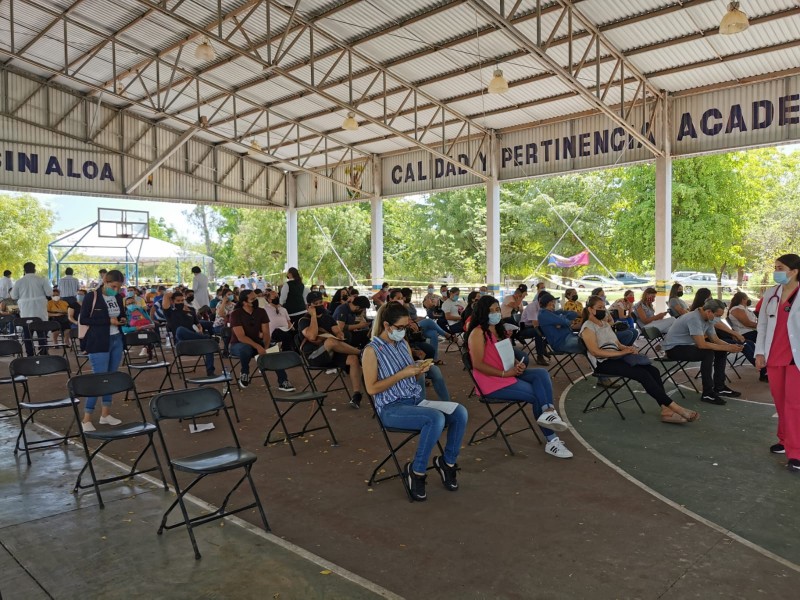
[80,269,127,431]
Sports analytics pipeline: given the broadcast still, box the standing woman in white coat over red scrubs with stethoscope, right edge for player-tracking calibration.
[756,254,800,472]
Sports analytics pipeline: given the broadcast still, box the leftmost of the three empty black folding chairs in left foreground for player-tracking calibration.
[9,356,81,464]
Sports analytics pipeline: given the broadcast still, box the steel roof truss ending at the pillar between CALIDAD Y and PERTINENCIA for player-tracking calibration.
[128,0,488,180]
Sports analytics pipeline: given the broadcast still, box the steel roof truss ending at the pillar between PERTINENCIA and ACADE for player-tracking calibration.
[467,0,663,156]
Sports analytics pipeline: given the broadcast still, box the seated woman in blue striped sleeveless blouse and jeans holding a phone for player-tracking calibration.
[362,302,467,502]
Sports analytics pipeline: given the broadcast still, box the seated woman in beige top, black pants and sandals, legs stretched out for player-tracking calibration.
[580,296,700,423]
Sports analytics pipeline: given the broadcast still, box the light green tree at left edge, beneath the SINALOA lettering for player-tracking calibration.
[0,194,55,278]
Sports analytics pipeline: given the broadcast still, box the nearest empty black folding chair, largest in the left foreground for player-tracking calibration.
[150,387,270,559]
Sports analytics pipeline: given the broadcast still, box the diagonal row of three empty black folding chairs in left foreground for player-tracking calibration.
[0,354,269,559]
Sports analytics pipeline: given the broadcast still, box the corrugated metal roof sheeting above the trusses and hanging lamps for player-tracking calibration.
[0,0,800,173]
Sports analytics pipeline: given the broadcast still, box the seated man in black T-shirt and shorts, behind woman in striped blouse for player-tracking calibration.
[297,292,362,408]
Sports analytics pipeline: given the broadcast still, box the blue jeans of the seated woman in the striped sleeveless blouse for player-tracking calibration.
[380,398,467,473]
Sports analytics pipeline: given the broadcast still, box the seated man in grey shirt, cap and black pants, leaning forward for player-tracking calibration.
[661,299,742,405]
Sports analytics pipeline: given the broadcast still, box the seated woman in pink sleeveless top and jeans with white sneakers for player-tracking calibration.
[467,294,572,458]
